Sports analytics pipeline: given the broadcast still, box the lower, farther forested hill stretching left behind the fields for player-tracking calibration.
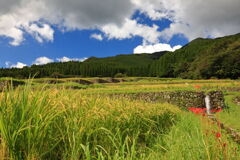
[0,52,168,78]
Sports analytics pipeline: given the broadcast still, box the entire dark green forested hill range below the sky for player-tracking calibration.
[0,34,240,79]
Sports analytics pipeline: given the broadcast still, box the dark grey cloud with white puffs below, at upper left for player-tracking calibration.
[0,0,133,46]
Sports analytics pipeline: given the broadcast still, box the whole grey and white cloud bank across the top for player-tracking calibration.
[0,0,240,46]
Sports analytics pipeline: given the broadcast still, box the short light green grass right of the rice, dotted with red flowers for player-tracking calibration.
[149,113,240,160]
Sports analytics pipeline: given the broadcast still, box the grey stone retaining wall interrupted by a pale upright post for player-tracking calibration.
[110,91,225,109]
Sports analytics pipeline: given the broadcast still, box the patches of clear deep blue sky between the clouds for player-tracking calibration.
[0,11,188,67]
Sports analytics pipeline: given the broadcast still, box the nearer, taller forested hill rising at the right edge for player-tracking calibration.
[152,34,240,79]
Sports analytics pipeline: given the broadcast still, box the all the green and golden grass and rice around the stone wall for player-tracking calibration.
[0,79,240,160]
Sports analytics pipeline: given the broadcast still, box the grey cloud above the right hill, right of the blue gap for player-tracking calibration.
[132,0,240,40]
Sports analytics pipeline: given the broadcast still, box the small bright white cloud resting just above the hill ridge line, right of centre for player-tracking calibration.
[133,43,182,54]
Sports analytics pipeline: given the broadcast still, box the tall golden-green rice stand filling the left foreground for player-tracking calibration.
[0,86,179,159]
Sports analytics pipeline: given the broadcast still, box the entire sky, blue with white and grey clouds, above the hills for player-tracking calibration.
[0,0,240,68]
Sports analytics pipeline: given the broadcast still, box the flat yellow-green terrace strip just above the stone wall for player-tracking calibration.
[76,80,240,93]
